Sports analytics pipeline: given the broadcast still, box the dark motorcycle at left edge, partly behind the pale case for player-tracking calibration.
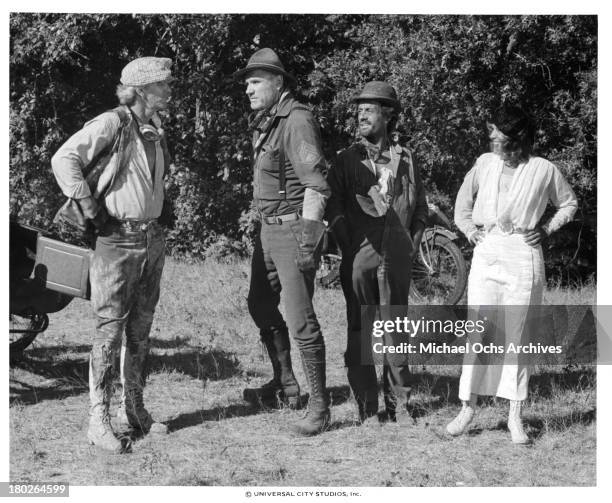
[9,219,74,360]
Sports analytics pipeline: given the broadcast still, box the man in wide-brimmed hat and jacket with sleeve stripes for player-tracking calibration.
[235,48,330,435]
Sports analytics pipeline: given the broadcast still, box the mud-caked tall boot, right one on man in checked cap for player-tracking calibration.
[117,339,167,434]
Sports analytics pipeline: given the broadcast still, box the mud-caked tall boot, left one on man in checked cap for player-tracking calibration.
[87,344,124,454]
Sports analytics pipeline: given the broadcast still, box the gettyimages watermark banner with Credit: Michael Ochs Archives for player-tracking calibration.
[361,305,612,365]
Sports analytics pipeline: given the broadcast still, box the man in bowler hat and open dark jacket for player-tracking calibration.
[326,81,427,421]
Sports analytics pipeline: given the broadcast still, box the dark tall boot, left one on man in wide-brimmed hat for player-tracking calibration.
[243,327,300,408]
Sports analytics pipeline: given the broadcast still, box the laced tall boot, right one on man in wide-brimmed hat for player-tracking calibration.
[292,344,330,435]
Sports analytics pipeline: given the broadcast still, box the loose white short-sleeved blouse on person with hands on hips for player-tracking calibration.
[455,153,578,238]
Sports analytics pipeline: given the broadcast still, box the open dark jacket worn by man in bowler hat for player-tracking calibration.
[325,143,428,259]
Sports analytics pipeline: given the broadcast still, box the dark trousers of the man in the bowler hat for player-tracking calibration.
[340,242,412,408]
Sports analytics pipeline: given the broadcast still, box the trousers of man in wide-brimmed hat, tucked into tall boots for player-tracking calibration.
[248,220,324,351]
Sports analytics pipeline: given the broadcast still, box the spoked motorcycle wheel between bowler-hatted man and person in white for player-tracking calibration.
[410,234,467,305]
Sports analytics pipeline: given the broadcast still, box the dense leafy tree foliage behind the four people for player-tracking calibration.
[10,14,597,279]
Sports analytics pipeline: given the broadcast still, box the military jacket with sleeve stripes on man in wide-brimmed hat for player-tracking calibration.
[253,93,330,216]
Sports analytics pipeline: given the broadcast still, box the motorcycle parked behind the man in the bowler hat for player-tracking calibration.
[316,203,467,305]
